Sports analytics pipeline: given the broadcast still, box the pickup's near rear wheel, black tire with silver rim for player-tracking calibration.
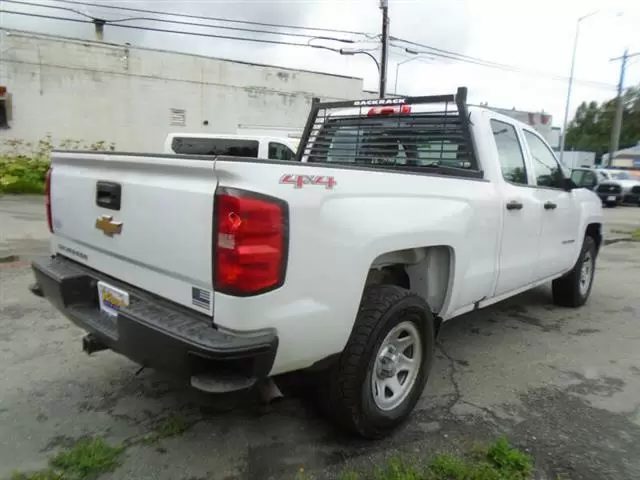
[325,285,435,438]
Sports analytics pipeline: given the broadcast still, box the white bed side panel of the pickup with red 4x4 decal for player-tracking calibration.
[214,157,502,373]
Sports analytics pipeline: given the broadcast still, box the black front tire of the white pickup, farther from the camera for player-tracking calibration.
[552,235,597,308]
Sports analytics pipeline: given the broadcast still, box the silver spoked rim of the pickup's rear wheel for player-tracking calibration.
[371,321,423,411]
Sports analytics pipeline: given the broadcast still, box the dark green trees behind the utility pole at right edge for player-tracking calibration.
[565,86,640,158]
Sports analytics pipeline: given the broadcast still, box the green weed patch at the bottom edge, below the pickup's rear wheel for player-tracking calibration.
[332,438,533,480]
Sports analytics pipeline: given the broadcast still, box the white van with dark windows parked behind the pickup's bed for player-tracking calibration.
[164,133,300,160]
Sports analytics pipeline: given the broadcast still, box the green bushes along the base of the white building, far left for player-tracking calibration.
[0,136,115,194]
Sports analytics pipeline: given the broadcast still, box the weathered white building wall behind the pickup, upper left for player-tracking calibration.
[0,29,362,152]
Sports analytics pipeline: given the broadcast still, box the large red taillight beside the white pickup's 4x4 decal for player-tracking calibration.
[213,189,289,296]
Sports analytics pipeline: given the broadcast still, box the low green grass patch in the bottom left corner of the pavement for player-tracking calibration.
[11,438,124,480]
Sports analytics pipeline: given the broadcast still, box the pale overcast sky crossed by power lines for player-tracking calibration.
[0,0,640,126]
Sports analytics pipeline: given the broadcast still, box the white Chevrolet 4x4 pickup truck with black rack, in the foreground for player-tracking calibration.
[33,88,602,438]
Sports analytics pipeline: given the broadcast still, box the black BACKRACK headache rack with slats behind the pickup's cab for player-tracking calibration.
[296,87,483,178]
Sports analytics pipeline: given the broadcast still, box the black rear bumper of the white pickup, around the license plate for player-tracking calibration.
[32,256,278,378]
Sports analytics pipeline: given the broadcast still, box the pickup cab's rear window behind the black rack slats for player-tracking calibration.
[309,115,471,168]
